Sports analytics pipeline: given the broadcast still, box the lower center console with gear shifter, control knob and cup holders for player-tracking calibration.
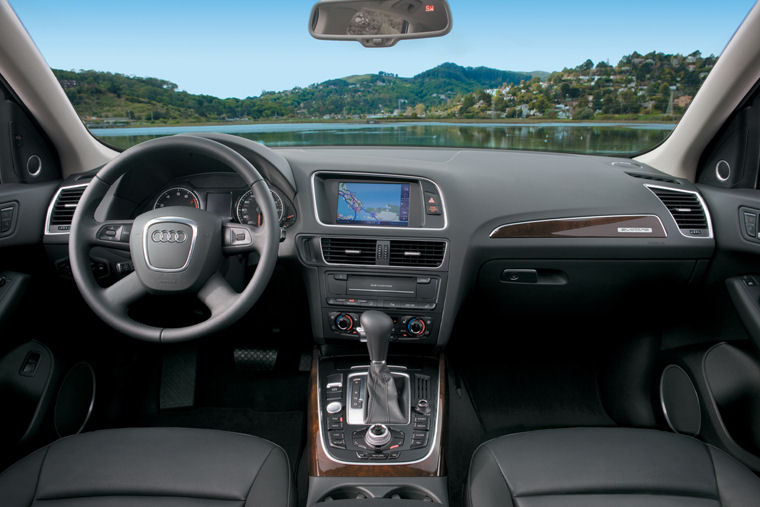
[307,310,447,506]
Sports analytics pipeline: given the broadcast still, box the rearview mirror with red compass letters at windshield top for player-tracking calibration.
[309,0,451,48]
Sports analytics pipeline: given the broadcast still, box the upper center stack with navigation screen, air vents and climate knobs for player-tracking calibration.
[297,172,449,345]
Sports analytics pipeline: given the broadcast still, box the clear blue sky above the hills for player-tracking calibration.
[10,0,754,98]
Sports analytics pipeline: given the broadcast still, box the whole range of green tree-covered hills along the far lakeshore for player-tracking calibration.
[53,51,717,125]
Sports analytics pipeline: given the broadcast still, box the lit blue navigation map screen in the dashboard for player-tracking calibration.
[337,182,409,227]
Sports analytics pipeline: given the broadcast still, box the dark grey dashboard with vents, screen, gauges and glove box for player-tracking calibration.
[44,135,715,346]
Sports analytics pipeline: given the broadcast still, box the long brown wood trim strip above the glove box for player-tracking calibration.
[491,215,668,238]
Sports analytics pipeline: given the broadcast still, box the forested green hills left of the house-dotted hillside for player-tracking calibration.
[53,63,532,123]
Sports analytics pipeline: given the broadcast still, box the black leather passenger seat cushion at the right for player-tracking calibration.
[467,428,760,507]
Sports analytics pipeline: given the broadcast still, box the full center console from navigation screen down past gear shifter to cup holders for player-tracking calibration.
[296,171,449,506]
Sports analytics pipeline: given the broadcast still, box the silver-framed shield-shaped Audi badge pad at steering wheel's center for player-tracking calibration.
[144,217,197,272]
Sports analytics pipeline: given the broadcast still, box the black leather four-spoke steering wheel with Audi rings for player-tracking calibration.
[69,135,279,343]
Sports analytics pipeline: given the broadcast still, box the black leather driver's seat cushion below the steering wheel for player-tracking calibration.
[0,428,294,507]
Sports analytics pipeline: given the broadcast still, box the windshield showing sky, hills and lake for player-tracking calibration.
[11,0,753,156]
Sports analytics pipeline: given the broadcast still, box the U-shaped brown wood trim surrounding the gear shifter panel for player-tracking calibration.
[307,350,446,477]
